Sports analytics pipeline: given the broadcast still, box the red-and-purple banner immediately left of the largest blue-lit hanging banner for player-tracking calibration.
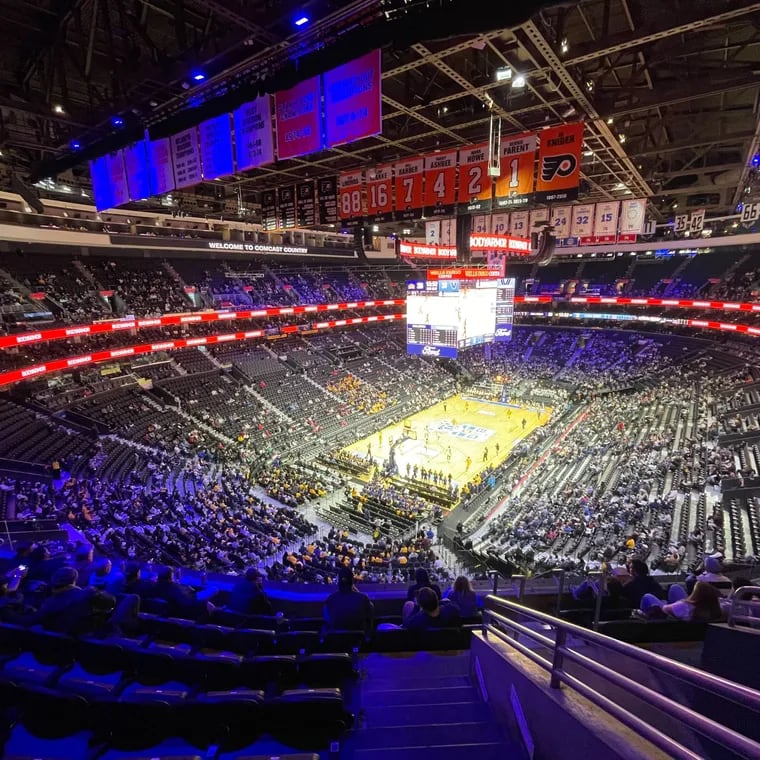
[274,77,322,161]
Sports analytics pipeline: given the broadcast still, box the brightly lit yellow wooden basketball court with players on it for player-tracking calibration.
[344,396,552,485]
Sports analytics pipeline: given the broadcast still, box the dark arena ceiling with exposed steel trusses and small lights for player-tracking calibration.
[0,0,760,217]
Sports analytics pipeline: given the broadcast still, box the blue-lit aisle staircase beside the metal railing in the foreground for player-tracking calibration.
[348,652,526,760]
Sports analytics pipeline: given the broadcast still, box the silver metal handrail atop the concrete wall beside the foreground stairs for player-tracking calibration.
[482,588,760,760]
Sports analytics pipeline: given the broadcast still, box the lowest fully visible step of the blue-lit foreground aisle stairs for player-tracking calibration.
[354,716,502,751]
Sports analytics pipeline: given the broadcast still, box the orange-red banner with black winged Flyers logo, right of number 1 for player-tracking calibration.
[536,121,583,203]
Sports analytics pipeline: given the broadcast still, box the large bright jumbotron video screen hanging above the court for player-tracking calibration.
[406,269,515,359]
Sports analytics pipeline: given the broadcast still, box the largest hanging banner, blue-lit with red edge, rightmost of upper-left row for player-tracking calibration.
[323,50,383,148]
